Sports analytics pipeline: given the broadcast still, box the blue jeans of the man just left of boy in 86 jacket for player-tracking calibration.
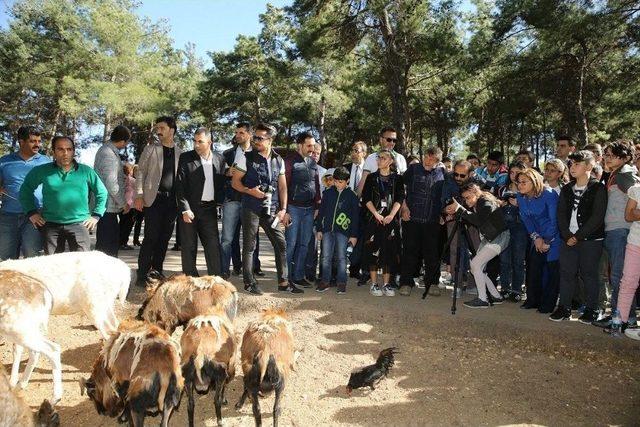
[284,206,313,282]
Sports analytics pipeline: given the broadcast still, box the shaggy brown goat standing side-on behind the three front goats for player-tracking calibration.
[137,274,238,334]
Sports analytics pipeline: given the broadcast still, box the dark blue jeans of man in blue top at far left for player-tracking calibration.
[0,213,42,260]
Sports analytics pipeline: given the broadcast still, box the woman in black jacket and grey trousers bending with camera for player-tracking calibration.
[450,183,509,308]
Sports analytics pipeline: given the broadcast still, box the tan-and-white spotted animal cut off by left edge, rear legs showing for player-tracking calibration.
[0,270,62,403]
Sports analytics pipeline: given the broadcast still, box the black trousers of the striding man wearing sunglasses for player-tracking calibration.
[240,209,288,285]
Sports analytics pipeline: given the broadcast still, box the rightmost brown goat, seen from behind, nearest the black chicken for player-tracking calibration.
[236,310,294,427]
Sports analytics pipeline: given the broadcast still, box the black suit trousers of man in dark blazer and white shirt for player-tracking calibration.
[178,202,222,277]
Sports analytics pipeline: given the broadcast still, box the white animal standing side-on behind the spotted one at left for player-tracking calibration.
[0,251,131,339]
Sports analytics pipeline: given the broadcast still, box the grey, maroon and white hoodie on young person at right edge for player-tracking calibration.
[604,165,640,231]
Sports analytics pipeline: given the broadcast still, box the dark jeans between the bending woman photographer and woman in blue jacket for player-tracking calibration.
[500,222,529,294]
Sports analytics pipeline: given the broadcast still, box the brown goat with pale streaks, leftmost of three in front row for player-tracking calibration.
[80,321,184,426]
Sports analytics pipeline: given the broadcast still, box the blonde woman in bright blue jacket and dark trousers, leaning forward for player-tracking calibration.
[516,169,560,313]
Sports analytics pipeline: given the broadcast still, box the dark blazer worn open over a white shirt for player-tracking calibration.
[175,150,225,214]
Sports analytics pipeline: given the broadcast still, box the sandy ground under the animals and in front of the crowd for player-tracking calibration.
[0,239,640,426]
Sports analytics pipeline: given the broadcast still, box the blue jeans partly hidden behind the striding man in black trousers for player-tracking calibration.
[220,201,260,276]
